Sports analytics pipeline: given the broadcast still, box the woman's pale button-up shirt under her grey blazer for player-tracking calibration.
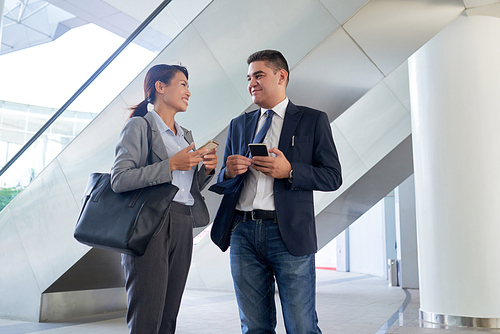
[151,110,196,205]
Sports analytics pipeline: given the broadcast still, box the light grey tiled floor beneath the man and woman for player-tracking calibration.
[0,270,500,334]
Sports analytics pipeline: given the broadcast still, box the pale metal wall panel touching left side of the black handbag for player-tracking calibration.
[9,160,84,292]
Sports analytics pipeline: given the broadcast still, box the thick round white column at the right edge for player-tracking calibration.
[409,16,500,327]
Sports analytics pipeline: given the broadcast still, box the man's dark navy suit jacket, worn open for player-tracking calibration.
[210,102,342,256]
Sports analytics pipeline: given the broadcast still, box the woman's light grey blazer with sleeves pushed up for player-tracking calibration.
[111,113,215,227]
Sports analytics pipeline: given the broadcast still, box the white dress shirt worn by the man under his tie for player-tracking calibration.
[236,98,288,211]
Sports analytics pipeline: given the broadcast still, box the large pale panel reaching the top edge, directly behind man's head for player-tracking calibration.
[193,0,339,103]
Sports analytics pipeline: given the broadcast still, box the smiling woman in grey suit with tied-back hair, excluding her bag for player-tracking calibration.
[111,64,217,334]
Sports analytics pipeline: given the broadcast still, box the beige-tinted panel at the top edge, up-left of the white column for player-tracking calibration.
[344,0,465,75]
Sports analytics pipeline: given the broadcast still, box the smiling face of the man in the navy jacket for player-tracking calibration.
[247,60,286,109]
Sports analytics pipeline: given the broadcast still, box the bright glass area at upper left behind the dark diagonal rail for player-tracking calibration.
[0,0,211,210]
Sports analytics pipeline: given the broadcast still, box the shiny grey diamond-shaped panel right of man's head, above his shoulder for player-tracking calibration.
[288,29,383,121]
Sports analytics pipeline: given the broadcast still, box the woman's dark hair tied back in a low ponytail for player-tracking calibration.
[130,64,188,117]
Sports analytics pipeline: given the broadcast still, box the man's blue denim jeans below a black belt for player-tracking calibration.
[231,215,321,334]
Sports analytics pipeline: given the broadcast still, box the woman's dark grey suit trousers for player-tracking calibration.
[122,202,193,334]
